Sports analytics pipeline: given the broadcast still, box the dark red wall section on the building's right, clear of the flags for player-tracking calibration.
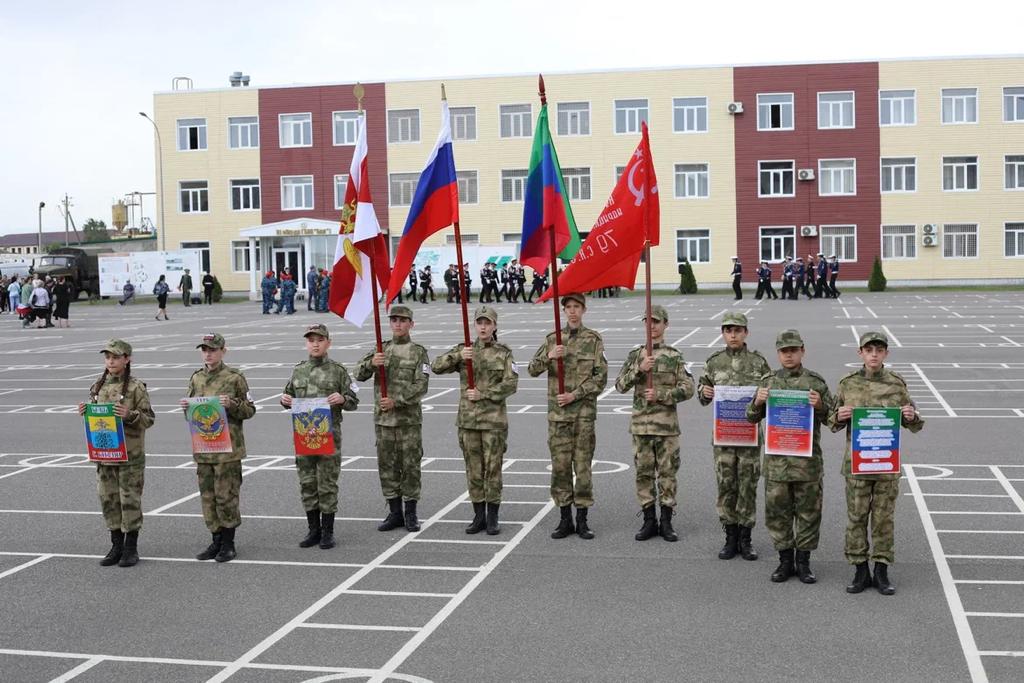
[722,62,882,281]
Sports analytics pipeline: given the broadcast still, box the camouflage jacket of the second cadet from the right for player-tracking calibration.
[746,367,833,481]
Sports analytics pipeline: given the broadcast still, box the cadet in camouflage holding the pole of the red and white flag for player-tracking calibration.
[355,305,430,531]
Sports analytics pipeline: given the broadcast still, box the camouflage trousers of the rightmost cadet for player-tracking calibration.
[846,477,899,564]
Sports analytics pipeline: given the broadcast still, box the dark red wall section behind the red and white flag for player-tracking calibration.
[259,83,388,230]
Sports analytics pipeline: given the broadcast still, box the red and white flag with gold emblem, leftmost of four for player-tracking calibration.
[328,114,390,328]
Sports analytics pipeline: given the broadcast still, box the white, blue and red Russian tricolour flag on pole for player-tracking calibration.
[387,100,459,304]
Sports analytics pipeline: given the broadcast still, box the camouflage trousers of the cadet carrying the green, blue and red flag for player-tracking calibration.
[548,420,597,508]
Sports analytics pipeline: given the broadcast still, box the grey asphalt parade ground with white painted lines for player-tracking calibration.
[0,292,1024,683]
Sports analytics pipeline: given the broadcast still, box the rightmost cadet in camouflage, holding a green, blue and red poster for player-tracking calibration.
[828,332,925,595]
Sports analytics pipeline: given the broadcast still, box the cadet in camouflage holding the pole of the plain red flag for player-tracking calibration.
[615,305,693,542]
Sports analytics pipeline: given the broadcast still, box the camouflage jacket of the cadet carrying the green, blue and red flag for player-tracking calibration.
[528,326,608,422]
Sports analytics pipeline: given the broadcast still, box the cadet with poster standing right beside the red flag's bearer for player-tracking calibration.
[697,311,771,560]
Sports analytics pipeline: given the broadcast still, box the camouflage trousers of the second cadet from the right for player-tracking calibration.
[765,479,821,550]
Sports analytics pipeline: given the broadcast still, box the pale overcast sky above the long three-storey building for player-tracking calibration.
[0,0,1024,233]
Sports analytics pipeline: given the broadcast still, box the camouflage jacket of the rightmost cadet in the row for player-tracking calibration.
[828,367,925,480]
